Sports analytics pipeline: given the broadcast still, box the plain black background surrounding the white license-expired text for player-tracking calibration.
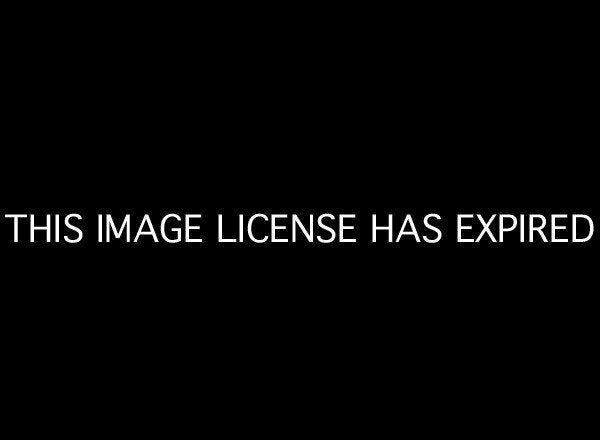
[1,5,598,433]
